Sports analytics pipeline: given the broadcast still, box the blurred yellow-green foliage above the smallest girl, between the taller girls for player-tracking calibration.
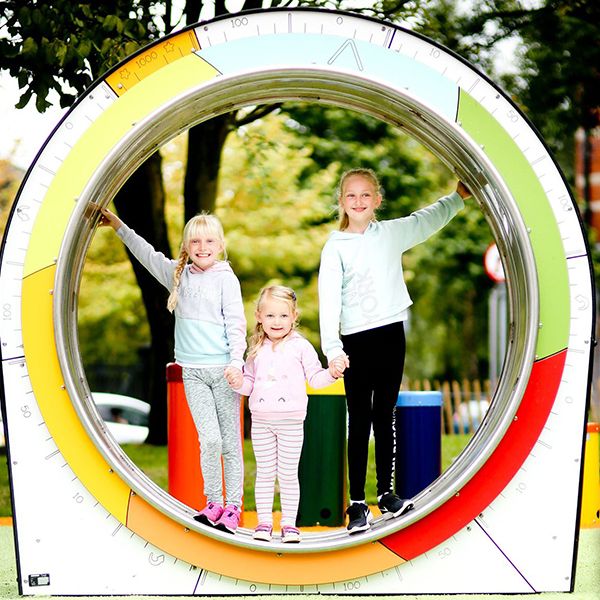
[216,114,337,347]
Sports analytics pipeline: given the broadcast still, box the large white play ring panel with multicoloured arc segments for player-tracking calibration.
[0,9,594,594]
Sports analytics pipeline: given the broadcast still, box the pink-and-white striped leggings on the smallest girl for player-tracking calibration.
[252,419,304,526]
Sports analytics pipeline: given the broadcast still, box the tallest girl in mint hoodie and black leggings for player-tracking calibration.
[319,169,470,533]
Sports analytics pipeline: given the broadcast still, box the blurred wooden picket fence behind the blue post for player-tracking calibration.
[400,378,491,435]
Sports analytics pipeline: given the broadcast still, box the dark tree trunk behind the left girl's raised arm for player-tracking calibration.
[115,153,174,445]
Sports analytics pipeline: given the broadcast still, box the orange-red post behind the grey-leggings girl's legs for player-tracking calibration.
[167,363,244,510]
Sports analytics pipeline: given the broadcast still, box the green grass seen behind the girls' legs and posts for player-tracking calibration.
[0,435,471,517]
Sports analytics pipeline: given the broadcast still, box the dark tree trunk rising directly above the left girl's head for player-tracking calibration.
[183,114,234,218]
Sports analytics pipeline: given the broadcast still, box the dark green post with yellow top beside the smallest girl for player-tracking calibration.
[297,379,346,527]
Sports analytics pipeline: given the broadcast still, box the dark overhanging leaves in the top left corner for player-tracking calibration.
[0,0,159,112]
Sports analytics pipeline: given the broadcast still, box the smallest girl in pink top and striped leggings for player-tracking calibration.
[233,285,343,542]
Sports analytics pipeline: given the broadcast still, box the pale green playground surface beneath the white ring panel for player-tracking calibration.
[0,519,600,600]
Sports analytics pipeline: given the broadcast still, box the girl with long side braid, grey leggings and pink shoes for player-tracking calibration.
[100,209,246,533]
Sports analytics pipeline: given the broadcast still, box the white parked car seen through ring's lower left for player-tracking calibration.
[92,392,150,444]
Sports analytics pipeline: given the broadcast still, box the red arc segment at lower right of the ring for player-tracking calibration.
[379,349,567,560]
